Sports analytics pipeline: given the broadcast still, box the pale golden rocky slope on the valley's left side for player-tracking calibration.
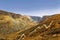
[0,10,36,40]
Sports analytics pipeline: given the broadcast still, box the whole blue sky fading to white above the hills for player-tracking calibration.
[0,0,60,16]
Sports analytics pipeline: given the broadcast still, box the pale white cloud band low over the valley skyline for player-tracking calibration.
[16,8,60,16]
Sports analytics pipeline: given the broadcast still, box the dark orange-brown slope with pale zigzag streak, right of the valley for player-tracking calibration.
[17,14,60,40]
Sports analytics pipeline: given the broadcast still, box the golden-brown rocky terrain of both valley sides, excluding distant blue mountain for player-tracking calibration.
[0,10,60,40]
